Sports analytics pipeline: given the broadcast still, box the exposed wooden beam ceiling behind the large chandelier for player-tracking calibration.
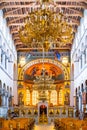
[0,0,87,50]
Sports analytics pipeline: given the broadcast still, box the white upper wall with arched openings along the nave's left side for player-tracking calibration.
[0,10,17,104]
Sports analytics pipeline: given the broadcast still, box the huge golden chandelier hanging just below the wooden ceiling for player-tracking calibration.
[19,2,73,50]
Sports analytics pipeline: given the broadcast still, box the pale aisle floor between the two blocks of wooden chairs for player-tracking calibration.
[34,124,54,130]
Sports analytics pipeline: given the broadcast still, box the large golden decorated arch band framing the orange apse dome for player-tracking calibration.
[18,59,70,80]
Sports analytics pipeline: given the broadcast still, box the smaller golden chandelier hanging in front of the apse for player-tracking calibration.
[33,68,55,101]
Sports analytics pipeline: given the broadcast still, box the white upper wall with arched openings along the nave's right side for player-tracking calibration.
[70,10,87,109]
